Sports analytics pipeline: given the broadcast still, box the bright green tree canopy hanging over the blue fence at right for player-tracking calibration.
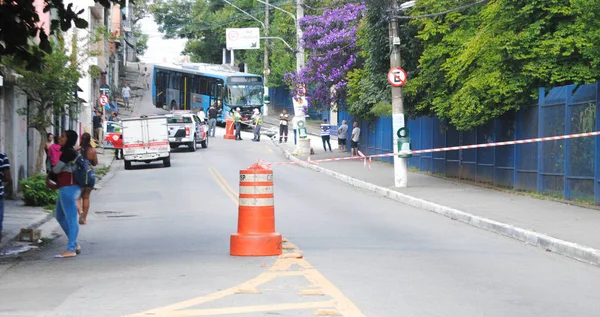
[405,0,600,130]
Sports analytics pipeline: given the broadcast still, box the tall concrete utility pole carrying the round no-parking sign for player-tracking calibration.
[390,0,408,187]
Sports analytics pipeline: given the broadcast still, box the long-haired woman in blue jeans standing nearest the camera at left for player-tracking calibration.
[52,130,81,258]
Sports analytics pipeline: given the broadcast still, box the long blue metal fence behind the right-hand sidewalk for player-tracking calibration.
[272,83,600,205]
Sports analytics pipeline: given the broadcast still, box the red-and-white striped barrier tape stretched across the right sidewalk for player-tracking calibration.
[275,131,600,165]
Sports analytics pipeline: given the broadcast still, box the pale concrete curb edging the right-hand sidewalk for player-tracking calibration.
[276,144,600,266]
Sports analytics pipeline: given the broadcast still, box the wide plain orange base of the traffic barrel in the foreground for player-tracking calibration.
[229,233,282,256]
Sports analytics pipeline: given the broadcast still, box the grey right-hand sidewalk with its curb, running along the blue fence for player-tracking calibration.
[276,132,600,266]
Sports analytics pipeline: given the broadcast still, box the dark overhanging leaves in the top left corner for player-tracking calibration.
[0,0,125,69]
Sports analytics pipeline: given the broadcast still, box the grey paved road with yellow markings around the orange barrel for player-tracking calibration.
[0,102,600,317]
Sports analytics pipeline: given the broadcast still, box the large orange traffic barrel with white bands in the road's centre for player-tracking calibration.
[230,161,281,256]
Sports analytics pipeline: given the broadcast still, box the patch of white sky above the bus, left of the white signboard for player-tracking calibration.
[139,17,186,64]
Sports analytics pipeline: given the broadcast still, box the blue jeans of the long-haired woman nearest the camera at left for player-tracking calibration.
[55,185,81,252]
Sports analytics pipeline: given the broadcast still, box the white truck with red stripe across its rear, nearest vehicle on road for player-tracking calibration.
[122,116,171,170]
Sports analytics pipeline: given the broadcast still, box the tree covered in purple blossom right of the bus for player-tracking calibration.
[286,4,366,107]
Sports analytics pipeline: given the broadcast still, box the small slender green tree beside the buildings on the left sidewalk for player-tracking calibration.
[10,45,80,173]
